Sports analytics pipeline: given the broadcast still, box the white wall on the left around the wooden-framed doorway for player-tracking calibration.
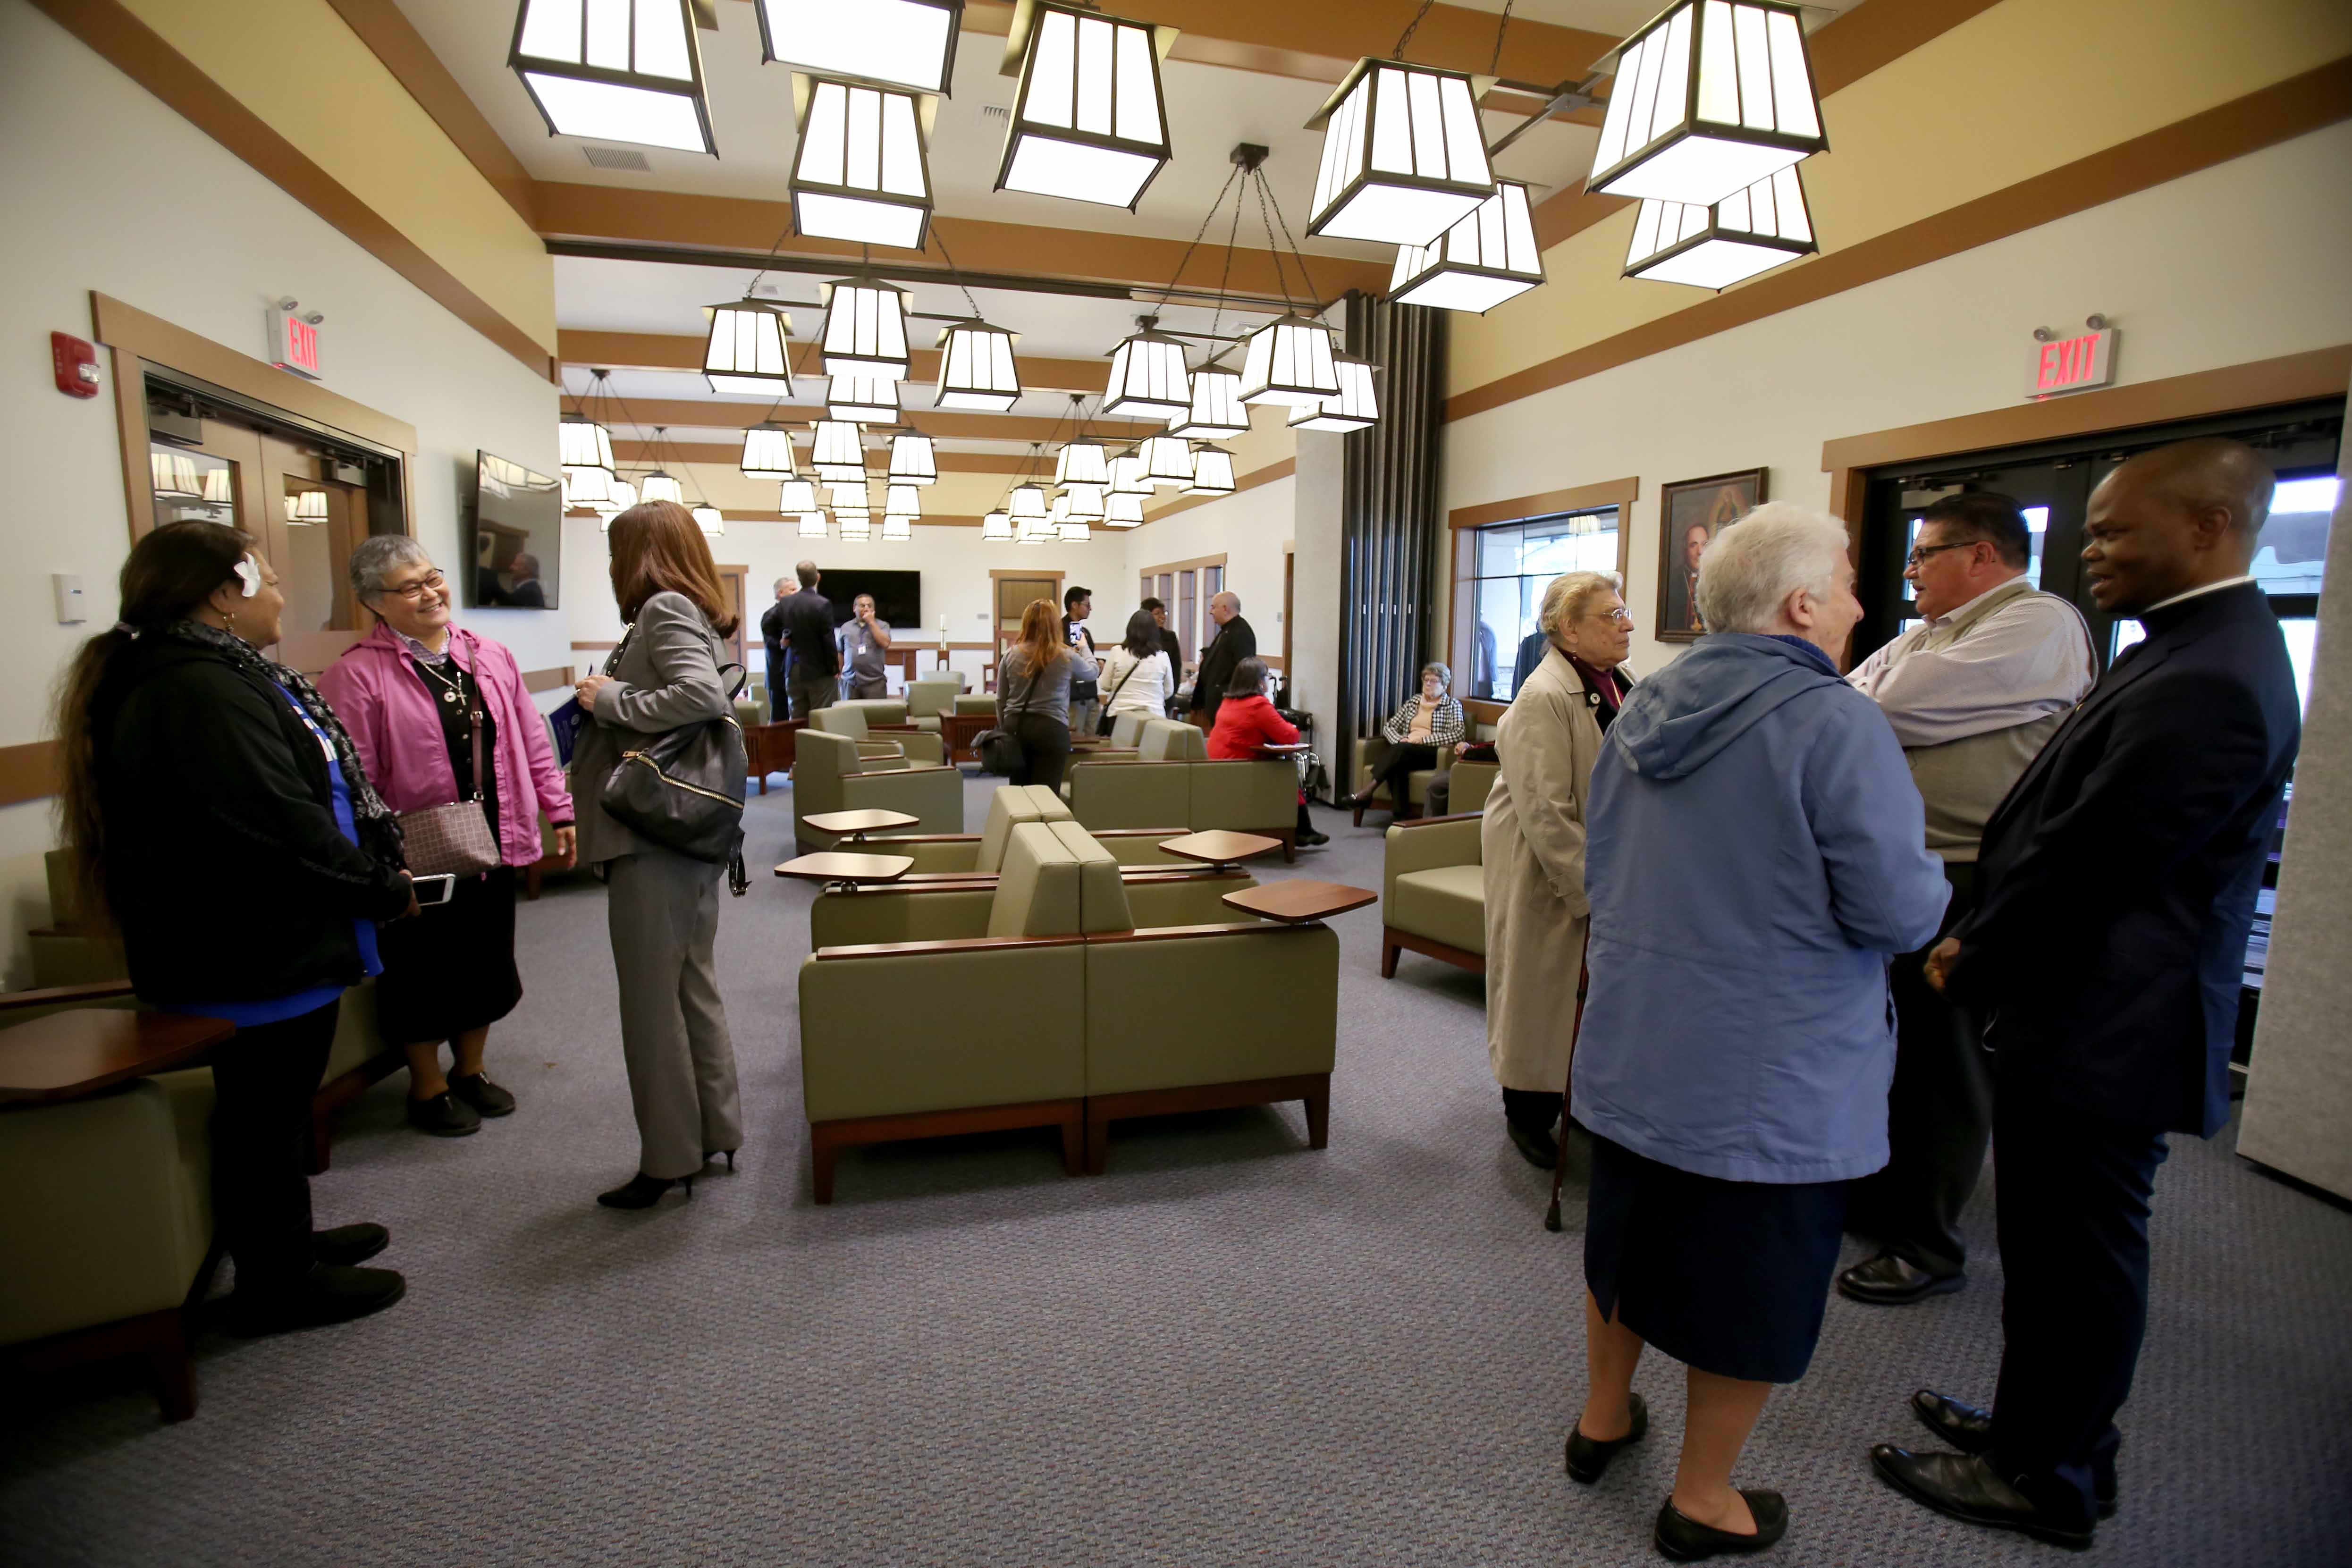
[0,0,569,985]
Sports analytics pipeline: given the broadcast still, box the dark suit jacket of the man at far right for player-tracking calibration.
[1950,583,2302,1138]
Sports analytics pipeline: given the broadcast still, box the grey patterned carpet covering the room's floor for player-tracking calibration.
[0,781,2352,1568]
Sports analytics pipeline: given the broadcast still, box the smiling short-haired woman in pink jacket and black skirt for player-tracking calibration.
[318,534,574,1138]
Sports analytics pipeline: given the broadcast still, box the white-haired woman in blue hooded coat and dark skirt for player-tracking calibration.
[1569,503,1947,1561]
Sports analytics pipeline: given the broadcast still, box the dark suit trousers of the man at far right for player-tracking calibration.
[1988,1072,2168,1528]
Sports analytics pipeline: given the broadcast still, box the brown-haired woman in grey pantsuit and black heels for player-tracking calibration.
[572,501,743,1208]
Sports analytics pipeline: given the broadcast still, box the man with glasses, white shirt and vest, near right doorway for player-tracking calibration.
[1837,491,2098,1307]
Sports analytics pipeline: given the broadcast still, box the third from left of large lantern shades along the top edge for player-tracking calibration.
[997,0,1176,209]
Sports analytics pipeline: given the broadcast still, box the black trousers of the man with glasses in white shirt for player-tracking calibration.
[1849,863,1992,1276]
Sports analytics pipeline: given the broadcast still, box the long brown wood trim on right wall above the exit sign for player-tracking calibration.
[1447,57,2352,423]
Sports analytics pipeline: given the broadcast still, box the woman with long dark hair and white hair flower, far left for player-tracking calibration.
[57,522,416,1333]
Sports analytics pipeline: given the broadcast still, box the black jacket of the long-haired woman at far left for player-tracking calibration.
[92,635,409,1002]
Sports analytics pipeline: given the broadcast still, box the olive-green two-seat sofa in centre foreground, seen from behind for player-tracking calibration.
[800,823,1338,1204]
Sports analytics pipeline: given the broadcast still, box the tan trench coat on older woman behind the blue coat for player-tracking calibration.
[1479,647,1602,1093]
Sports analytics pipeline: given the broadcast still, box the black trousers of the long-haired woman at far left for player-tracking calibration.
[211,997,344,1295]
